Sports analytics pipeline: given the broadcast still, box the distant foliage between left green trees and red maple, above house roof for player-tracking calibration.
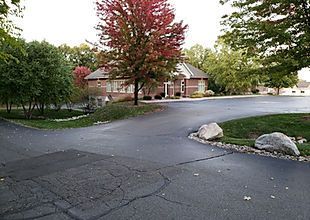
[59,44,98,71]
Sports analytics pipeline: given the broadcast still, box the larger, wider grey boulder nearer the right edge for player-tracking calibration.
[255,132,300,156]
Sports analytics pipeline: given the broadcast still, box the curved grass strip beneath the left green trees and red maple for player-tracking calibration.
[0,102,161,129]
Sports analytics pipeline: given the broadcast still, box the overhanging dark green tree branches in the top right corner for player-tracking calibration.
[221,0,310,77]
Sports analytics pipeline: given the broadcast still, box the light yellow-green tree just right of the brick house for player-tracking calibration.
[206,43,261,94]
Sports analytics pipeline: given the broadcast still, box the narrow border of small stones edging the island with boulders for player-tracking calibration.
[188,133,310,163]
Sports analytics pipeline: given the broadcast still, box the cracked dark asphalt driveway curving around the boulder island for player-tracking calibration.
[0,97,310,220]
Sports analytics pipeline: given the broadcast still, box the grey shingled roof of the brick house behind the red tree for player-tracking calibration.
[85,63,209,80]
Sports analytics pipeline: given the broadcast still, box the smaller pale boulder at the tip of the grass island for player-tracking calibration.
[198,123,223,140]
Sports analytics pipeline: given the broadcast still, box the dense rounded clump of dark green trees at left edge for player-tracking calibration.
[0,41,73,118]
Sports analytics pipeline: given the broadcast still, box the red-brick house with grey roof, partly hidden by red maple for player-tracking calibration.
[85,63,208,102]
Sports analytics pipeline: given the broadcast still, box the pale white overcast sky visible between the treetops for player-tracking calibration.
[16,0,310,81]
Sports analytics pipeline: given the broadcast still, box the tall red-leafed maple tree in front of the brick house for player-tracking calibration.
[97,0,187,105]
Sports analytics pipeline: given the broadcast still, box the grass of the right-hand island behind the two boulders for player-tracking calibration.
[220,113,310,156]
